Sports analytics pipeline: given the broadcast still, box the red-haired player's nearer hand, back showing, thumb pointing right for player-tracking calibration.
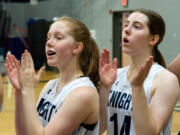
[19,50,45,89]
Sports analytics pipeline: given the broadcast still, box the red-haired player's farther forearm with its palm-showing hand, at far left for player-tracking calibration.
[5,51,43,135]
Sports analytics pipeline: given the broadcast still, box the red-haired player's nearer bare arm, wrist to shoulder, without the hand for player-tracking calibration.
[23,88,99,135]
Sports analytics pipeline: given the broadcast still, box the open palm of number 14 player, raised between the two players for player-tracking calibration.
[99,49,117,88]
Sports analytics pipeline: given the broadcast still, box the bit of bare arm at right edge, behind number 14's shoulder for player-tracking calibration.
[167,55,180,83]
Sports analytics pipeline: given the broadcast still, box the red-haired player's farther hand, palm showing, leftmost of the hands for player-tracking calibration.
[4,54,21,90]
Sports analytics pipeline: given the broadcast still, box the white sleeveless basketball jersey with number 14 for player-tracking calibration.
[107,64,172,135]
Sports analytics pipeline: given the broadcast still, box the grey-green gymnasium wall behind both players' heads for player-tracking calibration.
[2,0,180,63]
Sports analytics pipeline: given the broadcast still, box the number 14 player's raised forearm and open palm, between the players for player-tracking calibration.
[99,49,117,135]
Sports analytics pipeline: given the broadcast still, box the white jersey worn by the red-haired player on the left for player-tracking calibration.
[37,77,99,135]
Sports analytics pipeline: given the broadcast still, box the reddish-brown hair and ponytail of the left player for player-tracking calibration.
[58,16,100,89]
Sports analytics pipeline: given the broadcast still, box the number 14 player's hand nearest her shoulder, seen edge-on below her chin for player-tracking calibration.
[130,56,153,87]
